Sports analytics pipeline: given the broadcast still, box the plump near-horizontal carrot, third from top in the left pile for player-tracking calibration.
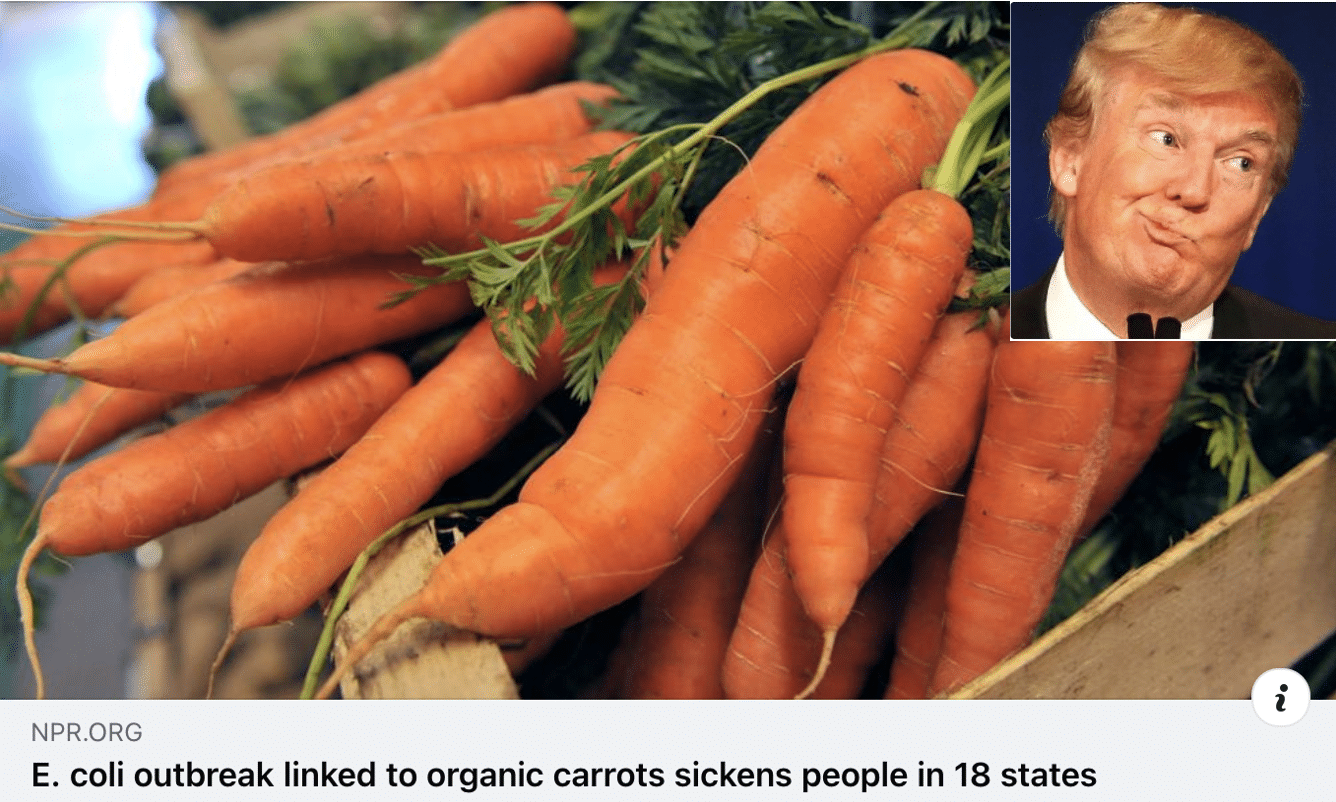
[164,131,631,262]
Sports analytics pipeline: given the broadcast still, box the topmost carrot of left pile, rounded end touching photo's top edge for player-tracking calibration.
[159,3,574,188]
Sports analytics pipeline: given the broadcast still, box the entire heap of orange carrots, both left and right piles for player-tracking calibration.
[0,3,1193,698]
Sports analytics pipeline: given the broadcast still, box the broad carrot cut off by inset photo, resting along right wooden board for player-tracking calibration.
[929,320,1117,695]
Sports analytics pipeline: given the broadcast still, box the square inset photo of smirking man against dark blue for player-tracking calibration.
[1011,3,1336,341]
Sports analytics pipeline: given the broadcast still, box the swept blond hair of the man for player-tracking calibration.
[1043,3,1304,234]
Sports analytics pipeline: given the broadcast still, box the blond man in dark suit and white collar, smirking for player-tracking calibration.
[1011,3,1336,340]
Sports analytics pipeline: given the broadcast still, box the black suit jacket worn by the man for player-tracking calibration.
[1011,269,1336,340]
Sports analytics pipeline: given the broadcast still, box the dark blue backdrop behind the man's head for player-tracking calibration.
[1011,3,1336,319]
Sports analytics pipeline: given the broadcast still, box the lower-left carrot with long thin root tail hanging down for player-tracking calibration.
[19,352,410,696]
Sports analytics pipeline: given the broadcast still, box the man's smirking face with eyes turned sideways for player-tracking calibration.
[1050,71,1277,320]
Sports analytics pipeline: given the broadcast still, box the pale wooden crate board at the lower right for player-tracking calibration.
[954,442,1336,699]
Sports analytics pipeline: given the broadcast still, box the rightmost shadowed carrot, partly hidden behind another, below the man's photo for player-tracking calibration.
[1077,340,1196,539]
